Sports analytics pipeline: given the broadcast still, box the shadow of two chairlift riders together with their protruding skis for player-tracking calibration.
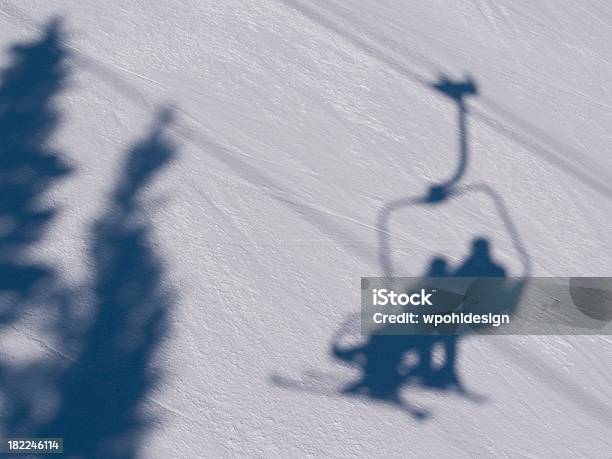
[271,237,520,421]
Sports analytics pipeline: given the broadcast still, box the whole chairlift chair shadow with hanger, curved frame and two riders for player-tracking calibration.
[331,76,530,419]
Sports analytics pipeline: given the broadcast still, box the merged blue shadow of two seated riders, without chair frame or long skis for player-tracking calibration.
[331,238,506,418]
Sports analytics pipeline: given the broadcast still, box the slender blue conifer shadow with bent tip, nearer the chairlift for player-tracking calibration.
[37,110,174,459]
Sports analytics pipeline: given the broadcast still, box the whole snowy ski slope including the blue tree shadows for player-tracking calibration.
[0,0,612,458]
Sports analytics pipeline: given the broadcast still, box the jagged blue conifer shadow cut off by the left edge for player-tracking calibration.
[0,19,71,329]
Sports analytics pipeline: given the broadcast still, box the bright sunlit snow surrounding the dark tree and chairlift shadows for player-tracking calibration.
[0,0,612,458]
